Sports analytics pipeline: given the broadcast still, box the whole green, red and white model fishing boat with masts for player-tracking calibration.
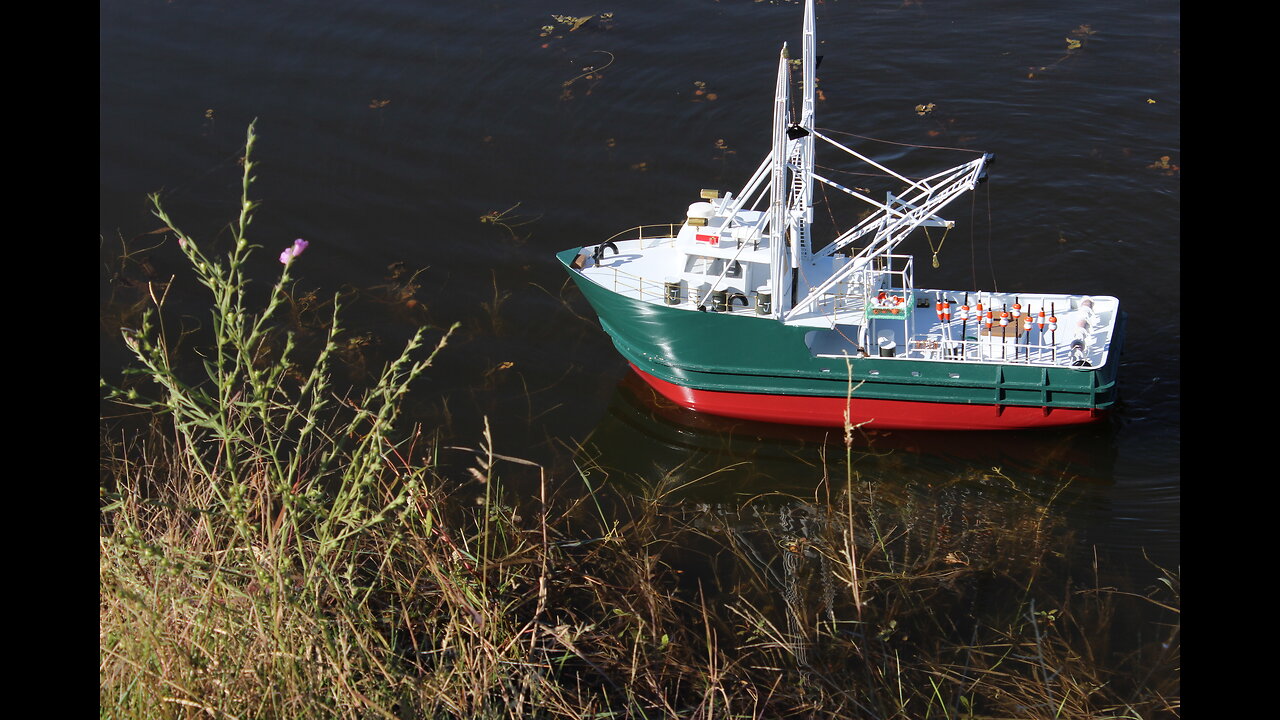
[557,0,1124,429]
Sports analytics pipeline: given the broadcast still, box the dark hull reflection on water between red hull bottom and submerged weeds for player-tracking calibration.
[584,363,1116,498]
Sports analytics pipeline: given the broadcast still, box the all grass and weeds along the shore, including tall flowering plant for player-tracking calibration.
[99,126,1180,720]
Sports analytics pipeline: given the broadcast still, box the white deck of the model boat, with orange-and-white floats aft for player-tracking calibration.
[581,235,1119,366]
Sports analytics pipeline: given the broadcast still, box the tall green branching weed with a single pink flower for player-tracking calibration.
[104,119,452,666]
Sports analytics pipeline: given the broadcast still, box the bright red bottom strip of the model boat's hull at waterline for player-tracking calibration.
[631,365,1106,430]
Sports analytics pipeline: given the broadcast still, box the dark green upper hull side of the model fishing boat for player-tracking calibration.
[557,249,1123,418]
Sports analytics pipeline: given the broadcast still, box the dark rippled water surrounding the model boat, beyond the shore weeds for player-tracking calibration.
[100,0,1181,599]
